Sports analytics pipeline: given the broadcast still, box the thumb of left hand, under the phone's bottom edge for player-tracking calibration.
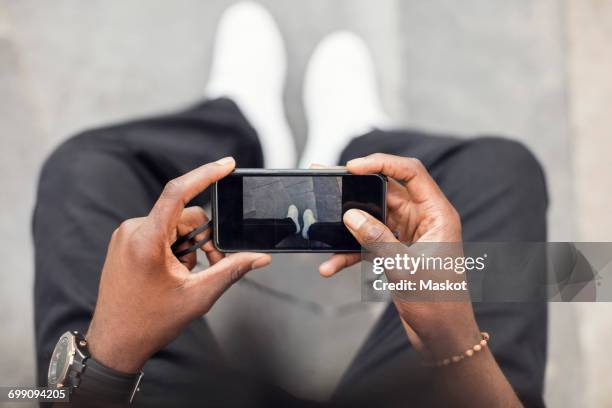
[190,252,272,311]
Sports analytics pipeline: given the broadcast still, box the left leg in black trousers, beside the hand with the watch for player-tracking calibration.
[33,99,308,405]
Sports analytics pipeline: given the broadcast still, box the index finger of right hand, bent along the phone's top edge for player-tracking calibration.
[346,153,445,202]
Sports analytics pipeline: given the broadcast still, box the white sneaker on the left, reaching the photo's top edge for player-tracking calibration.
[206,2,296,168]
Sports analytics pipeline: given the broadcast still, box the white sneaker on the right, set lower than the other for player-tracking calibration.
[300,31,390,167]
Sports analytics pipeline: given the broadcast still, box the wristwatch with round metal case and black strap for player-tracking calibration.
[47,331,143,403]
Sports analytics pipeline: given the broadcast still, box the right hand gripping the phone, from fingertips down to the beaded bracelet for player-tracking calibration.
[319,153,480,359]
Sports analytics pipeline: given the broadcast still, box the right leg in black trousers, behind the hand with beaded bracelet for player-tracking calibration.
[336,131,547,406]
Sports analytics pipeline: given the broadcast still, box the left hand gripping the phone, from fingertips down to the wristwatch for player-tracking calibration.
[86,157,271,373]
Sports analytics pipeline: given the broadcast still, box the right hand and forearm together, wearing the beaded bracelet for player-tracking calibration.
[319,153,521,407]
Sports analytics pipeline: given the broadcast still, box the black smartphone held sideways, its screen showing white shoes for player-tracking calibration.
[212,169,387,252]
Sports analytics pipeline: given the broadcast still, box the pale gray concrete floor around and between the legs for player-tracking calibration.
[0,0,612,407]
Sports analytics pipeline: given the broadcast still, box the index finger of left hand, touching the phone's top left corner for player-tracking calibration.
[148,157,236,237]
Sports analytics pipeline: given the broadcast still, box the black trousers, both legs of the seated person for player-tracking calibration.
[33,99,547,406]
